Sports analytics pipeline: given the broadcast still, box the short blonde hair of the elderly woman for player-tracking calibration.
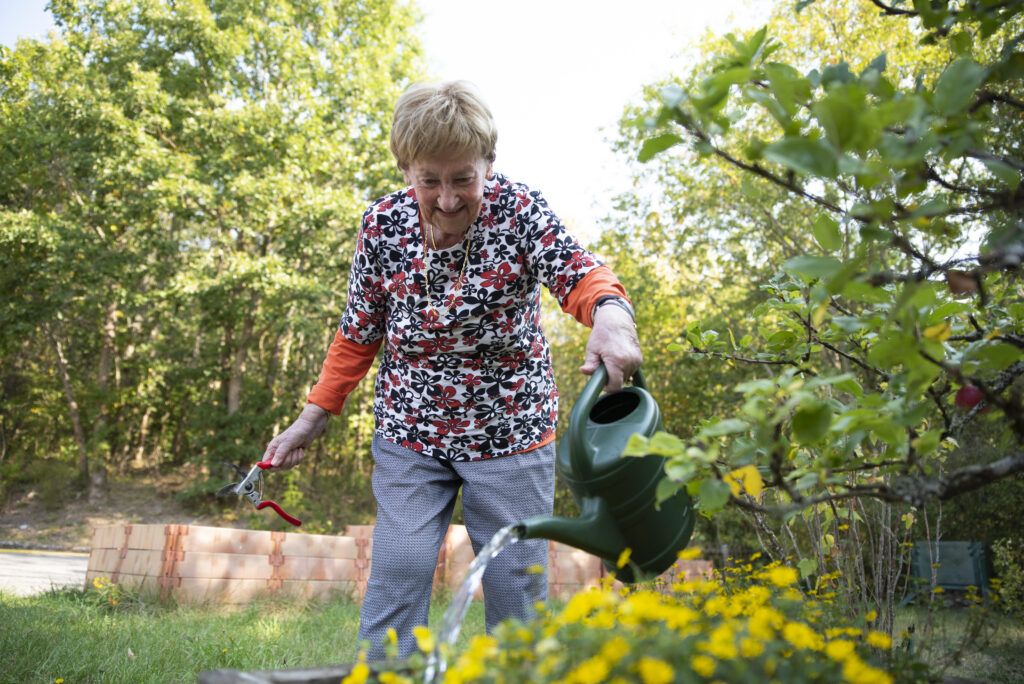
[391,81,498,170]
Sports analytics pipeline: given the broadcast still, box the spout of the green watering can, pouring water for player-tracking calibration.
[515,497,626,559]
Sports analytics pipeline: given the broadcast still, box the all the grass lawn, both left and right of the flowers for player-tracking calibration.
[0,588,1024,684]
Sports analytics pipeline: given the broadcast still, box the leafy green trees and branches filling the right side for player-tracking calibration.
[606,0,1024,627]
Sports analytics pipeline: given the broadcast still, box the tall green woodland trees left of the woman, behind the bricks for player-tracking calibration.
[0,0,420,520]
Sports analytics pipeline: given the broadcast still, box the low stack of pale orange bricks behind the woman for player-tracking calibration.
[86,525,711,604]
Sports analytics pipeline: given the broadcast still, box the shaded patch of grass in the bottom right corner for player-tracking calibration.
[894,606,1024,684]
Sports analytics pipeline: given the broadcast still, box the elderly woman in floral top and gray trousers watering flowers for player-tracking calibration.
[264,82,641,658]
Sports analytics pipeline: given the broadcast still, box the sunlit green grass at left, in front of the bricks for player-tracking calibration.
[0,590,483,684]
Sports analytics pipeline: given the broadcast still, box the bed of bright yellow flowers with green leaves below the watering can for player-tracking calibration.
[378,563,937,684]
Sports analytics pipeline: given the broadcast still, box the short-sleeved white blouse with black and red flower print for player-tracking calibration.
[339,174,601,461]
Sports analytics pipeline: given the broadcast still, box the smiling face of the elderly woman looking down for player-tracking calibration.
[402,155,490,239]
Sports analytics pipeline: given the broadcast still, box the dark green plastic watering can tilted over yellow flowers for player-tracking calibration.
[516,365,694,583]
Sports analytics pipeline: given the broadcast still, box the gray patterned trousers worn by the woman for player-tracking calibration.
[359,435,555,660]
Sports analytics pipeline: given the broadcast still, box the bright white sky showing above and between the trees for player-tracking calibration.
[0,0,774,239]
